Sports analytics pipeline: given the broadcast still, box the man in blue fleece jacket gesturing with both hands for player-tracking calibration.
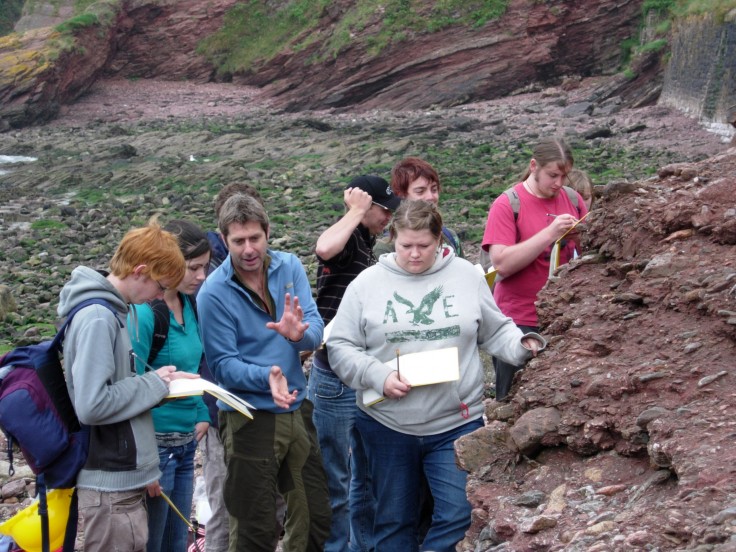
[197,194,331,552]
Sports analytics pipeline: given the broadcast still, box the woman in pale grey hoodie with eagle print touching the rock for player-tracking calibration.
[327,201,546,552]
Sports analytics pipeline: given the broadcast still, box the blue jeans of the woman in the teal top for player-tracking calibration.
[146,439,197,552]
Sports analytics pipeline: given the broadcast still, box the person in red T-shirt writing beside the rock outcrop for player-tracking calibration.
[482,138,588,400]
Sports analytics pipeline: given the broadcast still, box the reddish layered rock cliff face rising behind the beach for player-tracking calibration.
[0,0,642,127]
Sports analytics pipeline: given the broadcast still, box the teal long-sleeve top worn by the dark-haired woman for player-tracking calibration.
[128,298,210,433]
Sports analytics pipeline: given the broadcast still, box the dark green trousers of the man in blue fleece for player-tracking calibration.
[219,399,332,552]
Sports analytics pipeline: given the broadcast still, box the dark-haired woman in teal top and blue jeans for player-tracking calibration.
[128,220,210,552]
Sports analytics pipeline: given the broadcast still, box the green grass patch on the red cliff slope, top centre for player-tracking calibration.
[197,0,508,73]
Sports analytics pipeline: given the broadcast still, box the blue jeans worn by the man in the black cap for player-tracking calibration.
[307,359,375,552]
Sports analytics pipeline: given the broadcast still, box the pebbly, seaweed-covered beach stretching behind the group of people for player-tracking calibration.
[0,78,724,347]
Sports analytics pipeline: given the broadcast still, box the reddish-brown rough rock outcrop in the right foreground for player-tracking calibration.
[457,148,736,551]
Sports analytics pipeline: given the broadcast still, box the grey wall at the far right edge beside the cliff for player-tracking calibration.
[659,10,736,132]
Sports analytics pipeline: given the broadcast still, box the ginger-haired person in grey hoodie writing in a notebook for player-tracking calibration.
[58,222,199,551]
